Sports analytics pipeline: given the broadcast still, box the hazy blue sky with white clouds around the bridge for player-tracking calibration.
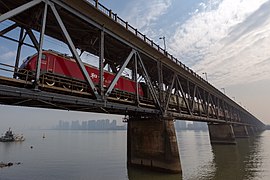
[0,0,270,129]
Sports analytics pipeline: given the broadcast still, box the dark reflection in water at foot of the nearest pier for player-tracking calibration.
[128,167,182,180]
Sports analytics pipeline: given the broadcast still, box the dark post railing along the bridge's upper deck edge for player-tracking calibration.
[87,0,209,84]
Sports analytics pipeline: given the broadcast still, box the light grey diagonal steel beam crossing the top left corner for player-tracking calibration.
[0,0,42,23]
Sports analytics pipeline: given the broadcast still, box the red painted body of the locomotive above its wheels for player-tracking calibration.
[19,50,144,96]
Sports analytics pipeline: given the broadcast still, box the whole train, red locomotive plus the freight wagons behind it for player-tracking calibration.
[17,50,232,117]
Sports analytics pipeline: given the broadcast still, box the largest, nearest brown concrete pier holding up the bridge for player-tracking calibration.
[127,117,182,173]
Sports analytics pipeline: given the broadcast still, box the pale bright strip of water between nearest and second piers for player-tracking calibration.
[177,131,215,180]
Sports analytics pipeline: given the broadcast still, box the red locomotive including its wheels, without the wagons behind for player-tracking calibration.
[18,50,146,96]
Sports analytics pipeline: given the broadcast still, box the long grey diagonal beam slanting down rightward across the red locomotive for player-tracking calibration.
[50,3,100,99]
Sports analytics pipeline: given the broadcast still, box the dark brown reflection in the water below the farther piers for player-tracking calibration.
[212,137,262,180]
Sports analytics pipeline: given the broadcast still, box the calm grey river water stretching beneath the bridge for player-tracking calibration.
[0,130,270,180]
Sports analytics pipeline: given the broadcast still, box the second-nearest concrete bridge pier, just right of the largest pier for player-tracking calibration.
[208,124,236,144]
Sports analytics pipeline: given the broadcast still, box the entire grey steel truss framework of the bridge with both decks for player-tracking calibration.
[0,0,264,127]
